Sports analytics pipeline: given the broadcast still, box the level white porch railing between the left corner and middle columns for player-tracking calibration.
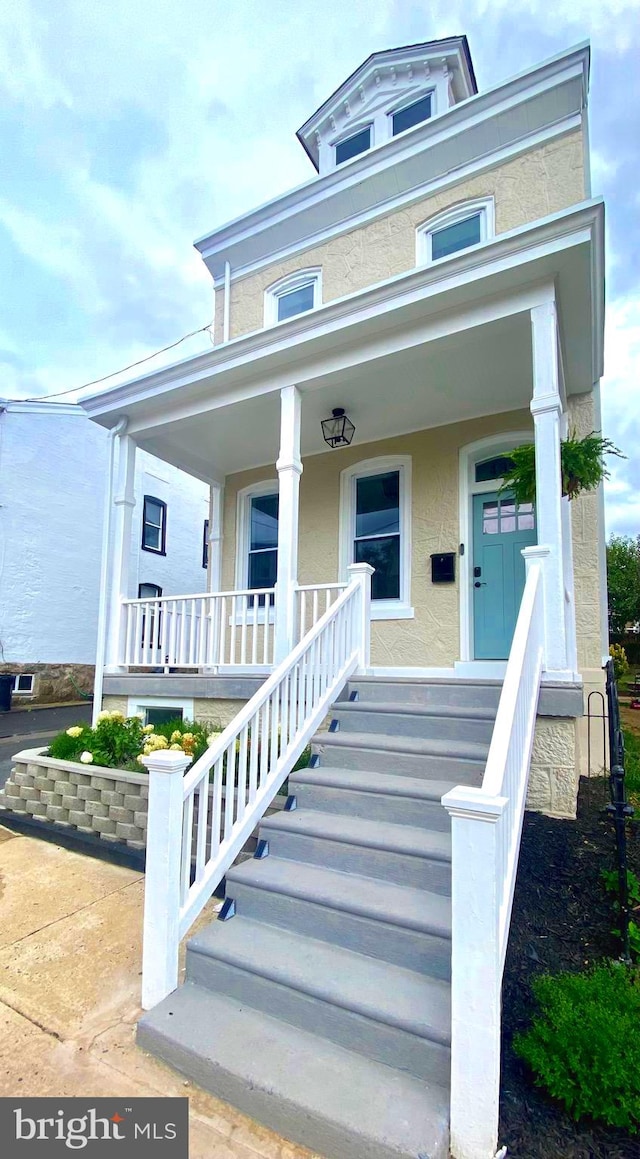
[122,588,275,669]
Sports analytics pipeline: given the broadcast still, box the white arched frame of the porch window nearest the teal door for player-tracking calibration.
[339,454,415,620]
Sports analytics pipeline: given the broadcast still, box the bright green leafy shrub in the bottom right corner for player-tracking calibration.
[514,962,640,1134]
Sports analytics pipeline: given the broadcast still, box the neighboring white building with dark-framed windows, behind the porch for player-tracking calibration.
[0,401,209,700]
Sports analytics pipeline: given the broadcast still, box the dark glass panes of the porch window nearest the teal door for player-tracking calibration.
[354,471,400,599]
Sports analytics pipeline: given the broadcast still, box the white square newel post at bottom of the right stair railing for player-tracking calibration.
[442,786,508,1159]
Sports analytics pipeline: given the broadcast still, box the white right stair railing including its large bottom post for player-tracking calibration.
[442,548,544,1159]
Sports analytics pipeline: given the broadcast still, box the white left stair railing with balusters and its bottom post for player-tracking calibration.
[138,563,373,1009]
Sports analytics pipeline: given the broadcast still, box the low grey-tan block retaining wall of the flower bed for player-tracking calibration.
[0,749,148,850]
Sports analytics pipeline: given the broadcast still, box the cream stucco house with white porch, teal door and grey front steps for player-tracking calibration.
[78,37,608,1159]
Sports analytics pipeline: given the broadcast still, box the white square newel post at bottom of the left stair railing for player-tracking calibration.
[141,750,191,1009]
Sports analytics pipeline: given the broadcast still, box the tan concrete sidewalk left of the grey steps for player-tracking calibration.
[0,826,320,1159]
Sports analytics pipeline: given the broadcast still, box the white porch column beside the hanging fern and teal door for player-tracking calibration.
[531,301,572,675]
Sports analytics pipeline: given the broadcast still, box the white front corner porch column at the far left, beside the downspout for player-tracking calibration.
[104,435,136,672]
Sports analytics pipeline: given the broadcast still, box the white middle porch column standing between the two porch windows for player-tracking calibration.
[275,386,303,664]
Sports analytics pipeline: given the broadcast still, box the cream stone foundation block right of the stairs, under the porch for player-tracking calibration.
[526,716,580,819]
